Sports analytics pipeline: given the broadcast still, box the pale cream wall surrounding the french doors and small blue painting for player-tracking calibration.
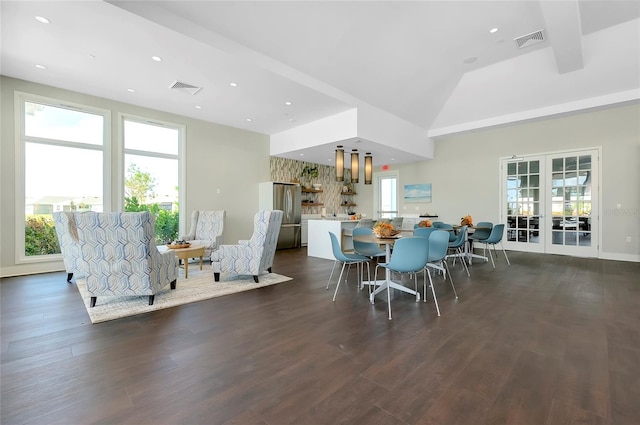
[358,103,640,261]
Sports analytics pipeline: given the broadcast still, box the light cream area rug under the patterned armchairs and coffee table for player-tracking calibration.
[76,265,291,323]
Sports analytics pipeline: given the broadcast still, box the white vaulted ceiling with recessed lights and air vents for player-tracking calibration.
[0,0,640,163]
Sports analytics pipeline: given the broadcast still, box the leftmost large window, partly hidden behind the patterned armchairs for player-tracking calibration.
[18,97,107,258]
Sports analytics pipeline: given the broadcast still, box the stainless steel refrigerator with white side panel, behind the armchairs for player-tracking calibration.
[258,182,302,249]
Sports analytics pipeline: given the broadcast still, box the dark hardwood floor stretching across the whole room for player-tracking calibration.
[0,249,640,425]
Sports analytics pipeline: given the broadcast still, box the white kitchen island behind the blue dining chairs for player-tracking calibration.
[307,217,359,260]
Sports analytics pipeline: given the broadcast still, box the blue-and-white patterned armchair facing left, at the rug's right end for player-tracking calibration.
[211,210,283,283]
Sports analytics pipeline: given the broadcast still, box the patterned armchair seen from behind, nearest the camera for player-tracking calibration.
[74,211,178,307]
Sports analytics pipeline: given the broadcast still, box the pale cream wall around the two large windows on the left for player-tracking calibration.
[0,77,270,276]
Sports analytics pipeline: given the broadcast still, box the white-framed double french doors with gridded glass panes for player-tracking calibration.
[501,149,600,257]
